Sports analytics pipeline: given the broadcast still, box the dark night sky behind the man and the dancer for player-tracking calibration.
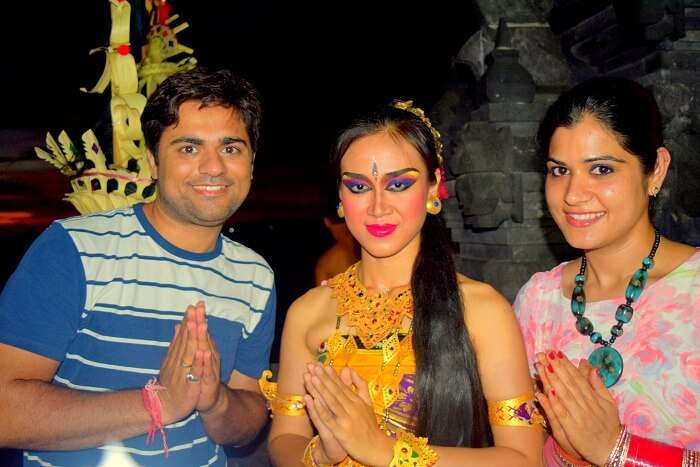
[0,0,480,380]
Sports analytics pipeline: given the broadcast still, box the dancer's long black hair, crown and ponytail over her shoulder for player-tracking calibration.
[332,107,493,447]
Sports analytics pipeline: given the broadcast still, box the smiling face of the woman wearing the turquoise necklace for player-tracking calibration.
[545,115,663,250]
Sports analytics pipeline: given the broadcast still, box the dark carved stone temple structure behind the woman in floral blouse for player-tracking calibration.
[432,0,700,300]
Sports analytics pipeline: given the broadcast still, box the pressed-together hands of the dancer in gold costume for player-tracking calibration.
[304,363,394,466]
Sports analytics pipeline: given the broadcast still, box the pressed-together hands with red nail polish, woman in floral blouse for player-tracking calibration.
[536,350,622,465]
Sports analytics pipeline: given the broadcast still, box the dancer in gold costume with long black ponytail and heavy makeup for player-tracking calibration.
[261,101,543,467]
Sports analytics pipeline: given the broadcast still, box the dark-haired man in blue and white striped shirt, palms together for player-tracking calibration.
[0,70,275,467]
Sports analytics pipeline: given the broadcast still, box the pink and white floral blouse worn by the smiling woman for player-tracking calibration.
[514,254,700,450]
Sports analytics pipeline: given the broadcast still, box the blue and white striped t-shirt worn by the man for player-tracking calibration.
[0,205,275,467]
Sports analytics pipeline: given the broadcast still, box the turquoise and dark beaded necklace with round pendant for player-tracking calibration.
[571,229,661,388]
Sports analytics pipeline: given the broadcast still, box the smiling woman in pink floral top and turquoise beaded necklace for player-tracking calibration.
[515,78,700,466]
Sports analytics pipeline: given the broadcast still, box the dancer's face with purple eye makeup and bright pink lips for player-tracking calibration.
[339,132,437,258]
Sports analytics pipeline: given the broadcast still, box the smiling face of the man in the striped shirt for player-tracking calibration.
[149,101,253,227]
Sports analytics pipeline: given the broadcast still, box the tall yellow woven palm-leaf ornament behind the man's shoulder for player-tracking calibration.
[34,0,196,214]
